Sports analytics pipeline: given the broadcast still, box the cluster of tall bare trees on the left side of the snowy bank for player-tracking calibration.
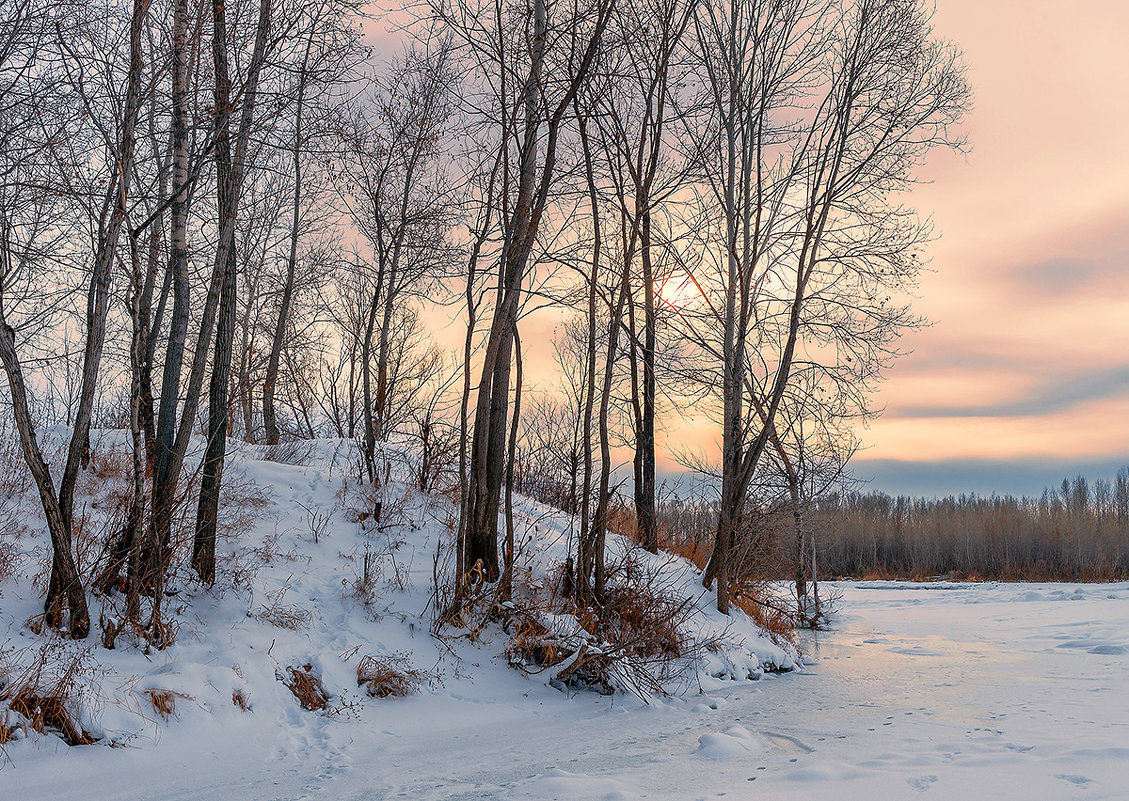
[0,0,370,639]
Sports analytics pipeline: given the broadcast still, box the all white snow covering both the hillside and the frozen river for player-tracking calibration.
[0,435,1129,801]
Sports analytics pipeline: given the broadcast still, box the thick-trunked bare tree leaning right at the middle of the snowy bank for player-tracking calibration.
[430,0,614,581]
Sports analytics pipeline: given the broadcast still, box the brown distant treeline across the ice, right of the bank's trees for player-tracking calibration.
[811,469,1129,581]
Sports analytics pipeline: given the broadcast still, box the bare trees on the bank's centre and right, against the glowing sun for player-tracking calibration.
[430,0,969,611]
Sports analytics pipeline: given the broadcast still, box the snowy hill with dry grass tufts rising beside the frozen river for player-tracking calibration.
[0,432,797,783]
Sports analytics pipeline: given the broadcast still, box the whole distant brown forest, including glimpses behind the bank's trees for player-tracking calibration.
[514,467,1129,581]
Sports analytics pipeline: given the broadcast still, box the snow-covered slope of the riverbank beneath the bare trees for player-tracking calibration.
[0,432,794,772]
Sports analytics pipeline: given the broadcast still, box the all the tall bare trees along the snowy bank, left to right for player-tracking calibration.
[0,0,969,638]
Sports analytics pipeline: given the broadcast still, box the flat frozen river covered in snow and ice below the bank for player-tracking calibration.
[11,583,1129,801]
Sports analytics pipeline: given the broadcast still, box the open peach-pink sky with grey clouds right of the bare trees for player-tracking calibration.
[388,0,1129,495]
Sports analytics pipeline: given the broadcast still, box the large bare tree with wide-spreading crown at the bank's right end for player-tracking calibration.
[681,0,968,612]
